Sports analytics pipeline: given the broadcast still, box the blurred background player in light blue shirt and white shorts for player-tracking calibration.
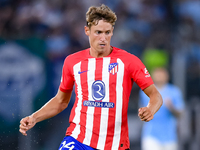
[140,67,184,150]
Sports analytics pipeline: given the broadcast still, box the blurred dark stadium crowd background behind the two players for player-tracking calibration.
[0,0,200,150]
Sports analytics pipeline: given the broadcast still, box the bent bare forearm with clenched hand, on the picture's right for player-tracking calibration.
[138,84,163,122]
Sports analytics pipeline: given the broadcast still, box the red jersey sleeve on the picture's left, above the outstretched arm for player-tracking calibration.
[59,57,74,92]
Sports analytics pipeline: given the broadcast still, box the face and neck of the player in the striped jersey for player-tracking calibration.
[85,20,113,57]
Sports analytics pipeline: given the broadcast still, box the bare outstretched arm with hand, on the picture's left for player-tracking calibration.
[19,90,72,136]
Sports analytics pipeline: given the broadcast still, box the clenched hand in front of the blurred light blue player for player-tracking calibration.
[138,107,153,122]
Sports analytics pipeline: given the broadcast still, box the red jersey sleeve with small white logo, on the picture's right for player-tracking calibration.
[130,56,153,90]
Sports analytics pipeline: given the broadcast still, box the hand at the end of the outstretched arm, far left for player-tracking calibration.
[19,116,36,136]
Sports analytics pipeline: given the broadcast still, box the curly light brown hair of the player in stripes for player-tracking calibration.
[86,4,117,28]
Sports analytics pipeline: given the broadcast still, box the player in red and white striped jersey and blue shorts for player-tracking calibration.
[20,4,162,150]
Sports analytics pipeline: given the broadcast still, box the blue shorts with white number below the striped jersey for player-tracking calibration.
[58,136,96,150]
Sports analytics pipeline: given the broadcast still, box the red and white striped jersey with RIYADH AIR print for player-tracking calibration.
[60,47,153,150]
